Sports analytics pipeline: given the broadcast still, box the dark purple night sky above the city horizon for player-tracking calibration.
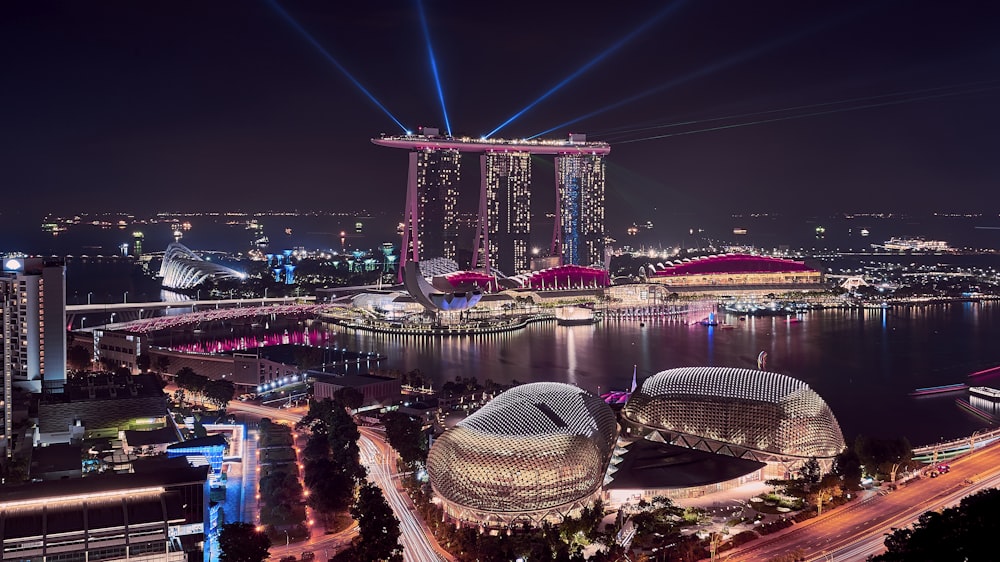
[0,0,1000,222]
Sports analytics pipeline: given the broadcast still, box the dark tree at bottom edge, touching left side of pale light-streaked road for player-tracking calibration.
[351,482,403,562]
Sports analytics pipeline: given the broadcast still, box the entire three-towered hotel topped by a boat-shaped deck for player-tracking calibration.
[372,128,611,275]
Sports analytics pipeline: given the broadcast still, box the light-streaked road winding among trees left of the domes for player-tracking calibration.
[229,402,453,562]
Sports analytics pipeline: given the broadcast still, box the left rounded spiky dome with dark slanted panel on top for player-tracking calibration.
[427,382,618,526]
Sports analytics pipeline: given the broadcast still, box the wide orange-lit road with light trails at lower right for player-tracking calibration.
[722,444,1000,562]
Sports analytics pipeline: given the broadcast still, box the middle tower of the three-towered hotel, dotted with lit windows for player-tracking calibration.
[482,152,531,275]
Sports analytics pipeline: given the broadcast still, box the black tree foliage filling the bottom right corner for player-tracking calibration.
[870,488,1000,562]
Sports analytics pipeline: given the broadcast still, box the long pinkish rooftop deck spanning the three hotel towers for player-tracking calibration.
[372,135,611,154]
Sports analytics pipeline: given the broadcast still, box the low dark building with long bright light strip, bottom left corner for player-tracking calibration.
[0,460,210,562]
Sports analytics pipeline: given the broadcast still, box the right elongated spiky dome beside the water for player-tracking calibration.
[622,367,845,469]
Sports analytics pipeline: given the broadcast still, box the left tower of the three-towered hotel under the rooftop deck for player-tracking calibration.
[408,144,461,259]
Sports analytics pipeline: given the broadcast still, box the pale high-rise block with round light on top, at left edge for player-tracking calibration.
[0,258,66,451]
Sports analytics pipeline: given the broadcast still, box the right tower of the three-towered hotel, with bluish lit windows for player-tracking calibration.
[556,154,604,267]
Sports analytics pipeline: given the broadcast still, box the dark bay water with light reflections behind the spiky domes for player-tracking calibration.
[337,303,1000,444]
